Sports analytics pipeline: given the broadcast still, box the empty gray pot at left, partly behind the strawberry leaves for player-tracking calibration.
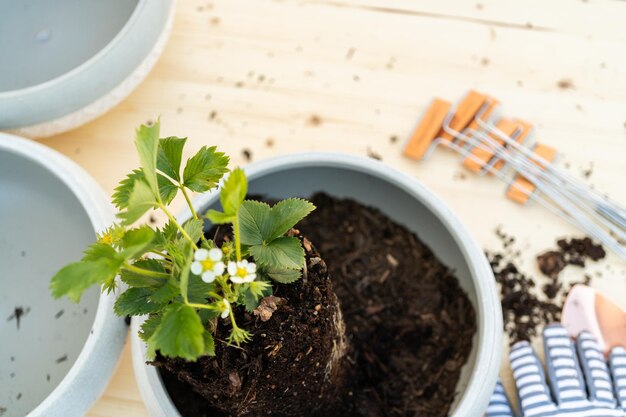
[0,133,127,417]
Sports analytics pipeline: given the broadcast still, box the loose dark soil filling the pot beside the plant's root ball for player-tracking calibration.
[161,194,476,417]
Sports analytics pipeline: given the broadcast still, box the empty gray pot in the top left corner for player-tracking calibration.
[0,0,174,137]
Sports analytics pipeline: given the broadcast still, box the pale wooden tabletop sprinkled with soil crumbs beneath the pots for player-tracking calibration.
[37,0,626,417]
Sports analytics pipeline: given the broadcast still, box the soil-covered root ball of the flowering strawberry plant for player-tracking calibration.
[155,228,349,416]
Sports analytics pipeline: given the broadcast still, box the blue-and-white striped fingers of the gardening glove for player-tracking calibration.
[487,324,626,417]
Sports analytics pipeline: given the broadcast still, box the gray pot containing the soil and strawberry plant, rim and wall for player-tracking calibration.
[131,153,502,417]
